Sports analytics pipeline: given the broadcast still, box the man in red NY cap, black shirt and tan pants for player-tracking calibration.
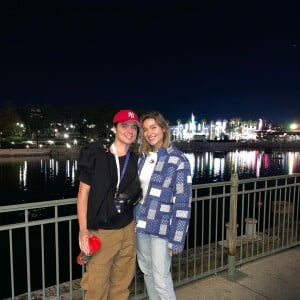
[77,109,140,300]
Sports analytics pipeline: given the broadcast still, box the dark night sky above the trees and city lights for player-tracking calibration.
[0,0,300,123]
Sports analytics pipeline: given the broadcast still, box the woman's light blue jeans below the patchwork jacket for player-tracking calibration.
[137,233,176,300]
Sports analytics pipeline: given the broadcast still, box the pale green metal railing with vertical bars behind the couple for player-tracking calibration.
[0,174,300,300]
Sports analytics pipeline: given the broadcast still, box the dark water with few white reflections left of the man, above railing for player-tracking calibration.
[0,157,78,205]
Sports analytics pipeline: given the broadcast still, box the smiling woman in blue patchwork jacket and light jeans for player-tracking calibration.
[135,112,192,300]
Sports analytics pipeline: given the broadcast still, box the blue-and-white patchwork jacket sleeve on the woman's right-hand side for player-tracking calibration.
[168,155,192,253]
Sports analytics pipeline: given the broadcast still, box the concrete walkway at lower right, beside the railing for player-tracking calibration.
[176,246,300,300]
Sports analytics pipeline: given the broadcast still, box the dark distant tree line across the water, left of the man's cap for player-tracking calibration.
[0,101,145,138]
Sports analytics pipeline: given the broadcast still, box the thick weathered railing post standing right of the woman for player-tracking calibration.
[228,173,239,275]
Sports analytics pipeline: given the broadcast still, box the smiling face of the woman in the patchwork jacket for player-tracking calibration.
[142,118,164,152]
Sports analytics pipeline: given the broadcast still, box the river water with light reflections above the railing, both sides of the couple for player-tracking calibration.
[0,150,300,205]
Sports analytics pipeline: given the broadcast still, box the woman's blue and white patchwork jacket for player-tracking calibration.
[136,146,192,253]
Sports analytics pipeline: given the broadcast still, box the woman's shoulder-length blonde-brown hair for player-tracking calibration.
[139,111,171,155]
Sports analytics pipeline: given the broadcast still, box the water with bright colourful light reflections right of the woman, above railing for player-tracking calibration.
[186,150,300,184]
